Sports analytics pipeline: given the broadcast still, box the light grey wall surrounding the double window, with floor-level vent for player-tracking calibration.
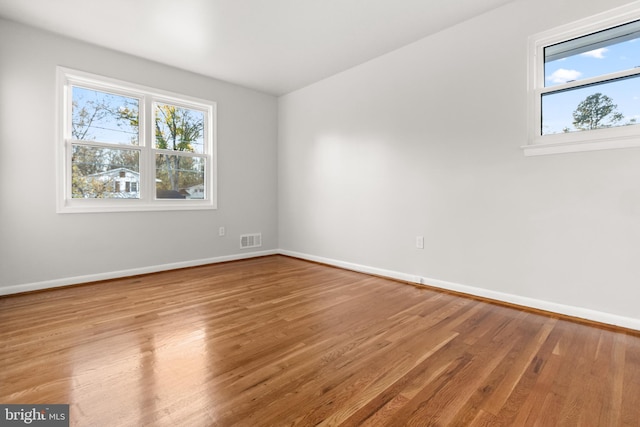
[0,20,278,294]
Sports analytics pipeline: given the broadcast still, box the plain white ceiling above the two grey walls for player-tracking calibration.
[0,0,512,95]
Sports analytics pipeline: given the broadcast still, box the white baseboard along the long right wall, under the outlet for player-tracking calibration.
[279,250,640,330]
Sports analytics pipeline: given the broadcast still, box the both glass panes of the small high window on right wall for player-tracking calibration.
[540,21,640,135]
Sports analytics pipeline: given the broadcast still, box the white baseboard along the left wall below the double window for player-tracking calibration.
[0,249,279,295]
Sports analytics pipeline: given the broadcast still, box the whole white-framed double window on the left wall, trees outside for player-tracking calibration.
[58,67,216,212]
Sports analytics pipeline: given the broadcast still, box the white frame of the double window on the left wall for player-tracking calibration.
[56,67,217,213]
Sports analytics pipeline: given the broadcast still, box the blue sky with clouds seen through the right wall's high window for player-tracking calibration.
[542,39,640,134]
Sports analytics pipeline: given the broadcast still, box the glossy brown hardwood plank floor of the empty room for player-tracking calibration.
[0,256,640,426]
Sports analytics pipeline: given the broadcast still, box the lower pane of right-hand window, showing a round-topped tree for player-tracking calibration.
[542,76,640,135]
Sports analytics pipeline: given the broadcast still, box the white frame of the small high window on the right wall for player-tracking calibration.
[522,1,640,156]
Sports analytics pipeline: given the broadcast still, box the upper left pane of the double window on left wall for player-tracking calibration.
[71,86,139,145]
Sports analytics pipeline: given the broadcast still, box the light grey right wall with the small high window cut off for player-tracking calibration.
[278,0,640,329]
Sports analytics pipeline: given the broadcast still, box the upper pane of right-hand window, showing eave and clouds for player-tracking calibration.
[544,21,640,87]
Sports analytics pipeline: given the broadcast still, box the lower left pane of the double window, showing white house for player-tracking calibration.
[71,145,140,199]
